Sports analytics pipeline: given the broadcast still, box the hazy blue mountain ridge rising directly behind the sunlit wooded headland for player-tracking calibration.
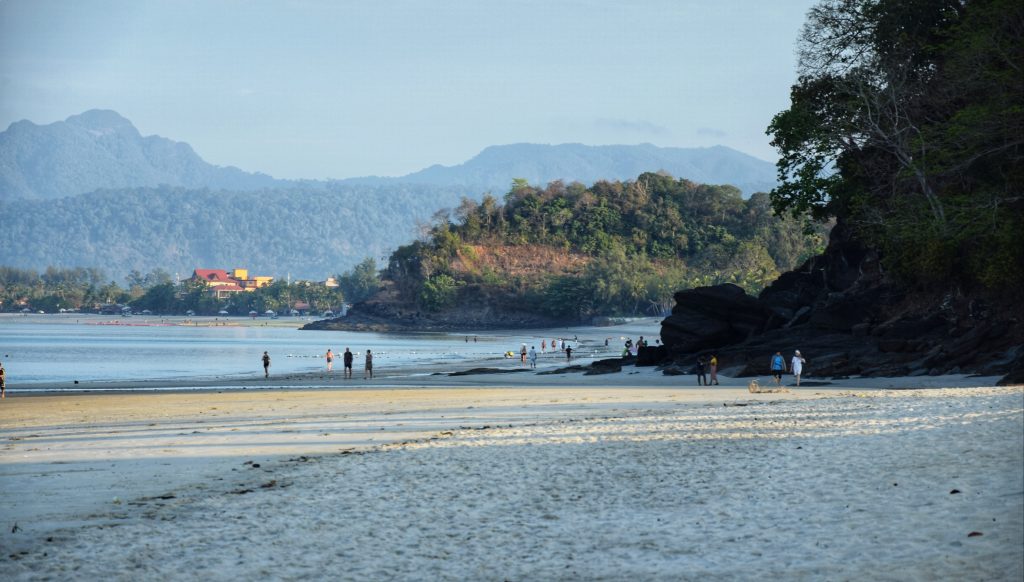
[342,143,775,197]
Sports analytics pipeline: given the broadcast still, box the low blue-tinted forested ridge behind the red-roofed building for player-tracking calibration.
[0,184,474,280]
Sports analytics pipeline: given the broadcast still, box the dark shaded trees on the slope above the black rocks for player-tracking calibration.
[768,0,1024,293]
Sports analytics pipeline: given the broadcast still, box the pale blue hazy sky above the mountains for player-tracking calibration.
[0,0,814,178]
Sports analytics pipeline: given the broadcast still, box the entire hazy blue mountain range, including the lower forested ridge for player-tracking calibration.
[0,110,774,279]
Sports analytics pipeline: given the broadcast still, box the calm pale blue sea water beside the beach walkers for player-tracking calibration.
[0,314,528,389]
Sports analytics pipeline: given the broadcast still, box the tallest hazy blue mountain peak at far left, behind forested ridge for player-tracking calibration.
[0,110,284,200]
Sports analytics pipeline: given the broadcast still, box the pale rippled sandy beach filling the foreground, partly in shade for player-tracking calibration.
[0,372,1024,580]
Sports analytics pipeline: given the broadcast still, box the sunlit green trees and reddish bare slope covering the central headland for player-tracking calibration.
[386,173,827,319]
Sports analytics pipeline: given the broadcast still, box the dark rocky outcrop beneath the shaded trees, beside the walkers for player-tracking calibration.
[662,223,1024,382]
